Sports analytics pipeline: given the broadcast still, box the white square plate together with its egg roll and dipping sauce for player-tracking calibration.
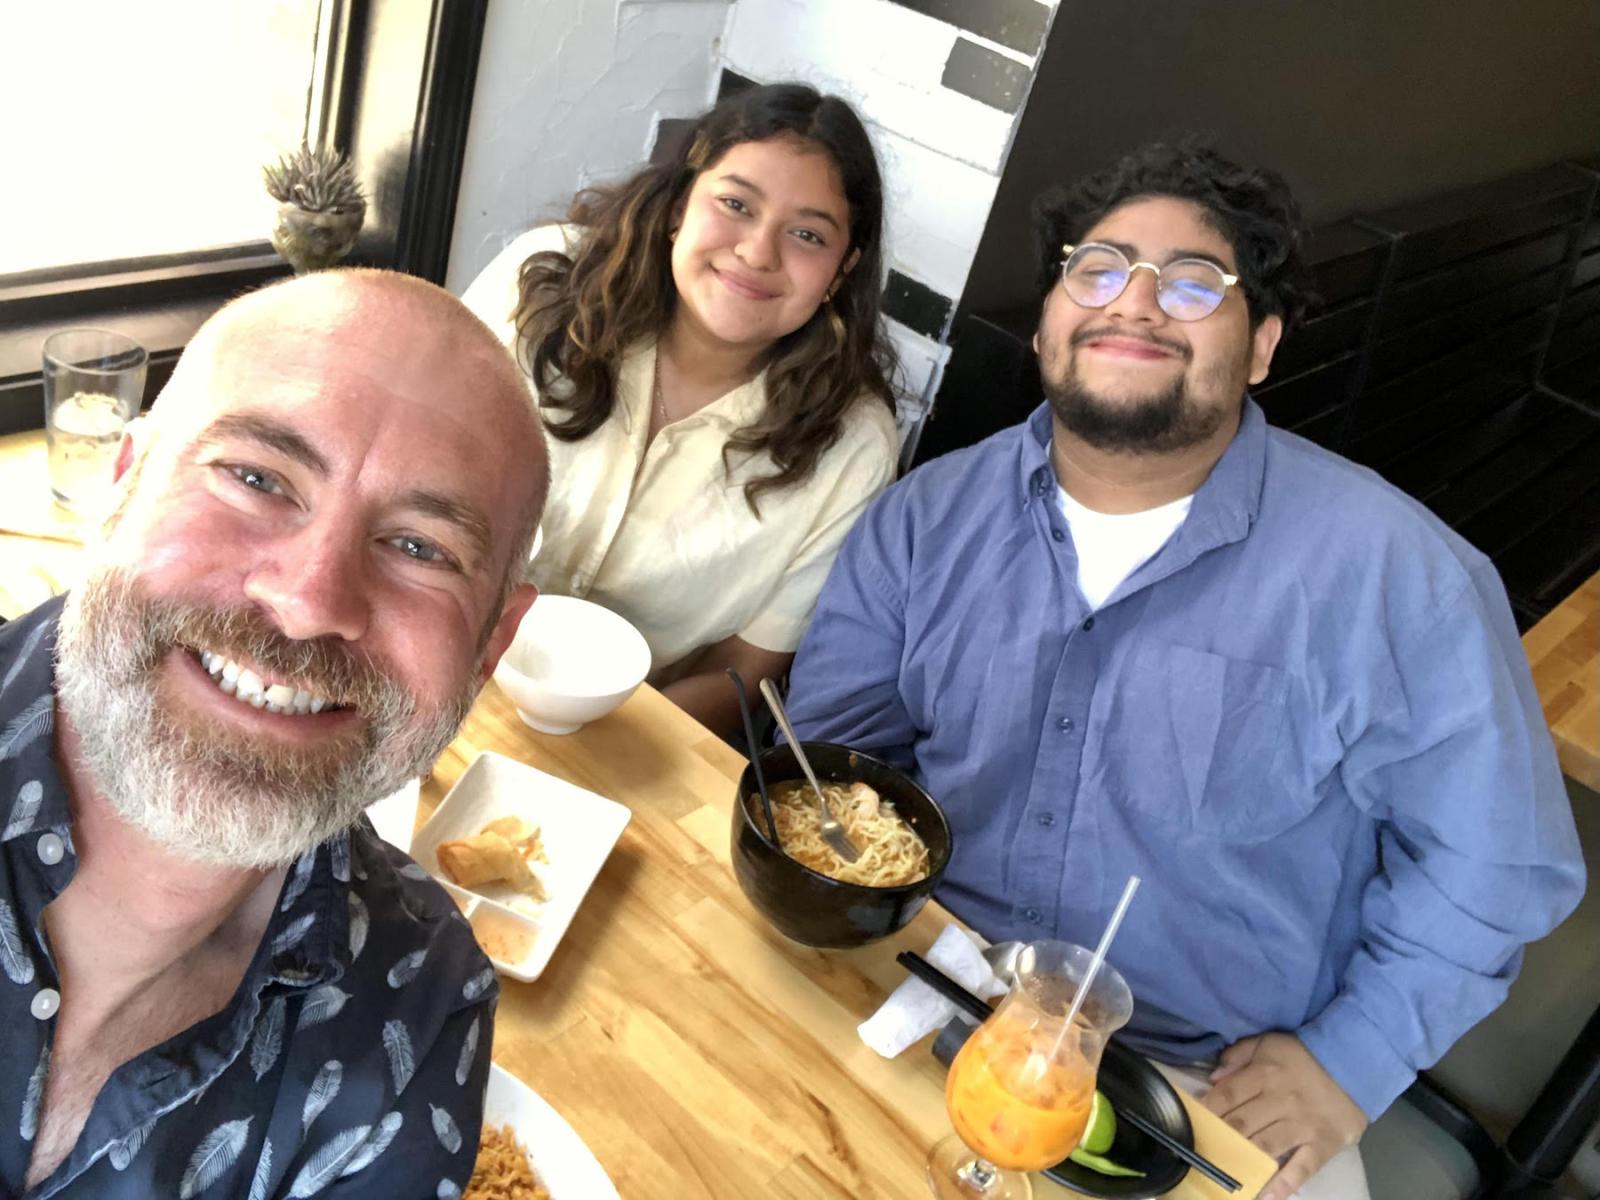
[411,750,632,982]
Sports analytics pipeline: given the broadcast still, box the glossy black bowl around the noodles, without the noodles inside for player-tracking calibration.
[733,742,950,947]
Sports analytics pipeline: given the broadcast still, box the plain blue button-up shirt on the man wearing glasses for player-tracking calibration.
[790,400,1584,1117]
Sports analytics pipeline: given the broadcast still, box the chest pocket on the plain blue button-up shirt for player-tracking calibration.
[1085,638,1315,842]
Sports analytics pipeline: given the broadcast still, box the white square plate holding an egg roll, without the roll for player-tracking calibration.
[411,750,632,982]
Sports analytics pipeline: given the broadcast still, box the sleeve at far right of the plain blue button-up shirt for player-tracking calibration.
[1299,565,1584,1118]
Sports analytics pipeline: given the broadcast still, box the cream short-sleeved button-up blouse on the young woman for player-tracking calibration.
[462,226,899,683]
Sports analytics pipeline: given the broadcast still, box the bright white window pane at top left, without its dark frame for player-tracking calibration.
[0,0,318,277]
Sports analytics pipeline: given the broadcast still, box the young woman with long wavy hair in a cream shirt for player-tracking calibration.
[464,85,899,731]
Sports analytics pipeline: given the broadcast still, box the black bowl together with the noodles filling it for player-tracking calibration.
[730,742,950,947]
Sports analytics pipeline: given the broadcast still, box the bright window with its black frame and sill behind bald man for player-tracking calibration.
[0,0,488,434]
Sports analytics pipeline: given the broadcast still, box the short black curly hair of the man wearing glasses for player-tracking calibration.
[1034,136,1314,330]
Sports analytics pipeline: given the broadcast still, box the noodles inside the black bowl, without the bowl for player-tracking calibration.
[755,779,928,888]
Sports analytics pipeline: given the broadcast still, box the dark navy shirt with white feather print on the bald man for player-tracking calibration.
[0,600,499,1200]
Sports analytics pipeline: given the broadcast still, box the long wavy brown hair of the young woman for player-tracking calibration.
[515,83,894,514]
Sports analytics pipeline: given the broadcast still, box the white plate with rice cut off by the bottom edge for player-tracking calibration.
[464,1064,618,1200]
